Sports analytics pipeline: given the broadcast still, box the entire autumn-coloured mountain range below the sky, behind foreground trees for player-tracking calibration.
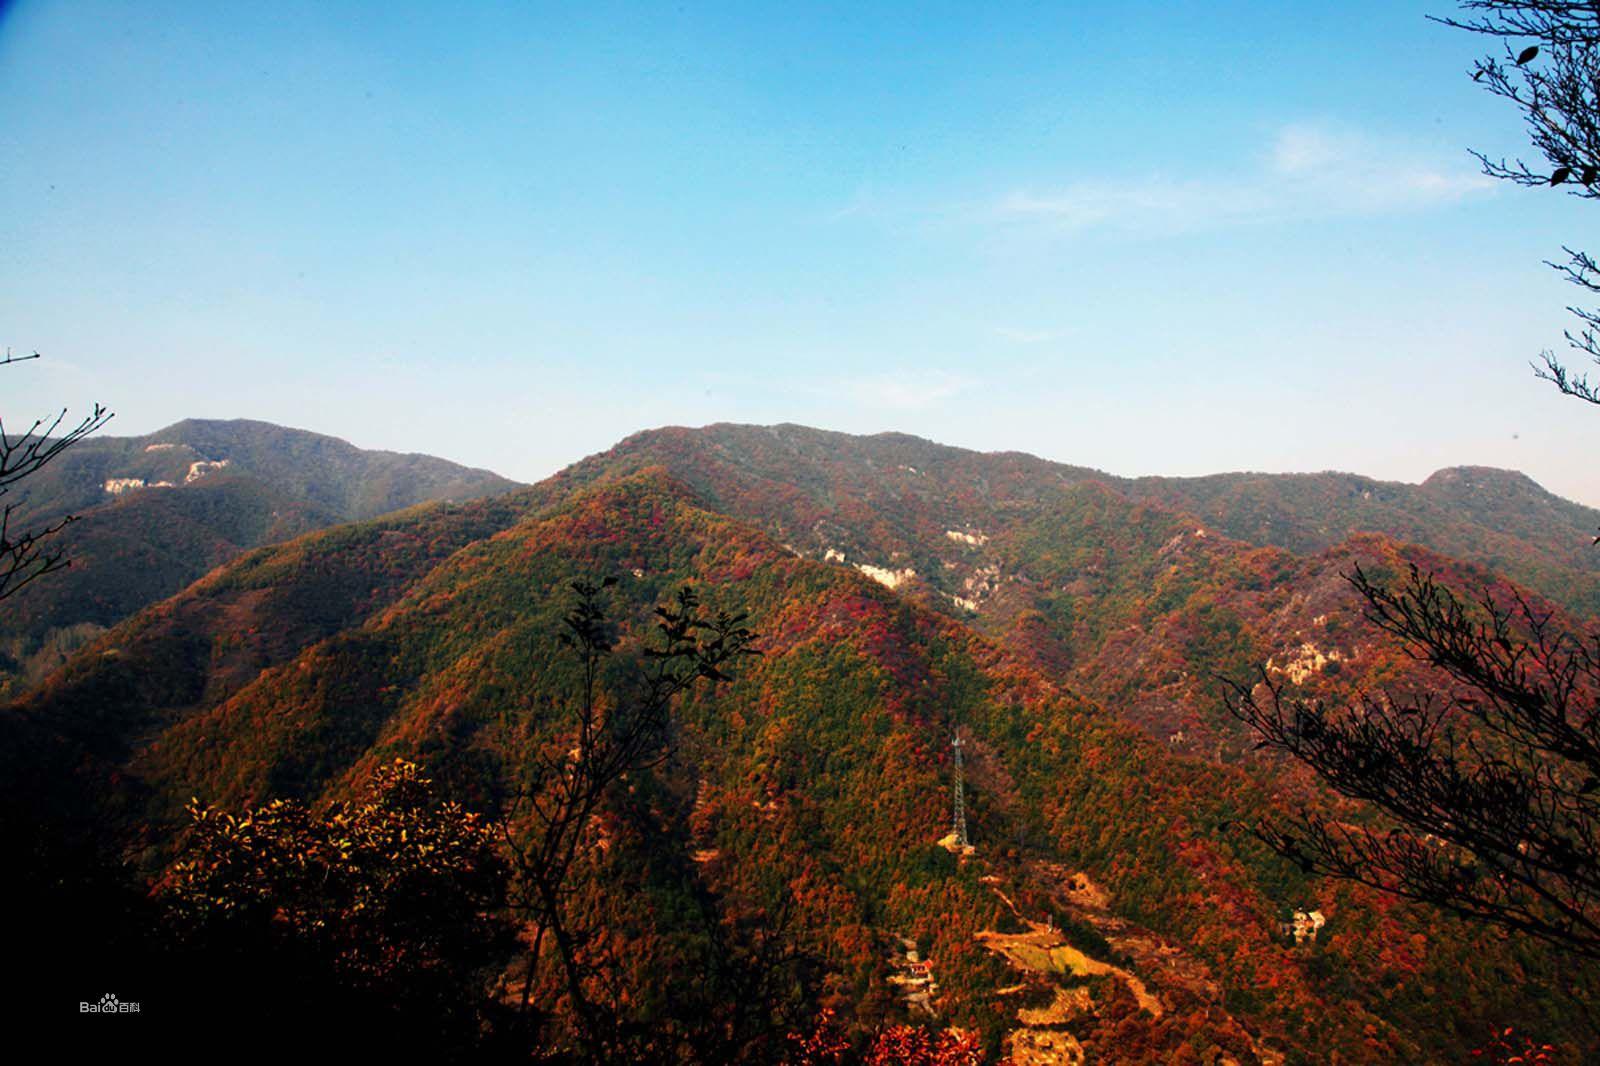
[0,423,1600,1063]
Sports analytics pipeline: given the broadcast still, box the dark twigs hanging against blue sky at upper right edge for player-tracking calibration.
[1437,0,1600,403]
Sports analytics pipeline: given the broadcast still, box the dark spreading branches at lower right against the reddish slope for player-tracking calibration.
[1226,567,1600,957]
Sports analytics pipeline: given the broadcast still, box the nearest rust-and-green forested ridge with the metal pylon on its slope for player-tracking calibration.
[6,454,1592,1063]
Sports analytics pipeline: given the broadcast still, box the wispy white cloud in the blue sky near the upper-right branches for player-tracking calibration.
[986,125,1494,234]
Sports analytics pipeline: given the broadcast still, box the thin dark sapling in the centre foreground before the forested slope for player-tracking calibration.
[501,578,757,1060]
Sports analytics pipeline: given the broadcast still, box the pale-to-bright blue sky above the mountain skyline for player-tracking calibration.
[0,0,1600,504]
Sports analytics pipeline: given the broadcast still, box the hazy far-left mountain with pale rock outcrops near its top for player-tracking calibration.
[0,419,515,688]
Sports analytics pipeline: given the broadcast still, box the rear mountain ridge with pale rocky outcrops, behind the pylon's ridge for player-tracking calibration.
[554,426,1600,759]
